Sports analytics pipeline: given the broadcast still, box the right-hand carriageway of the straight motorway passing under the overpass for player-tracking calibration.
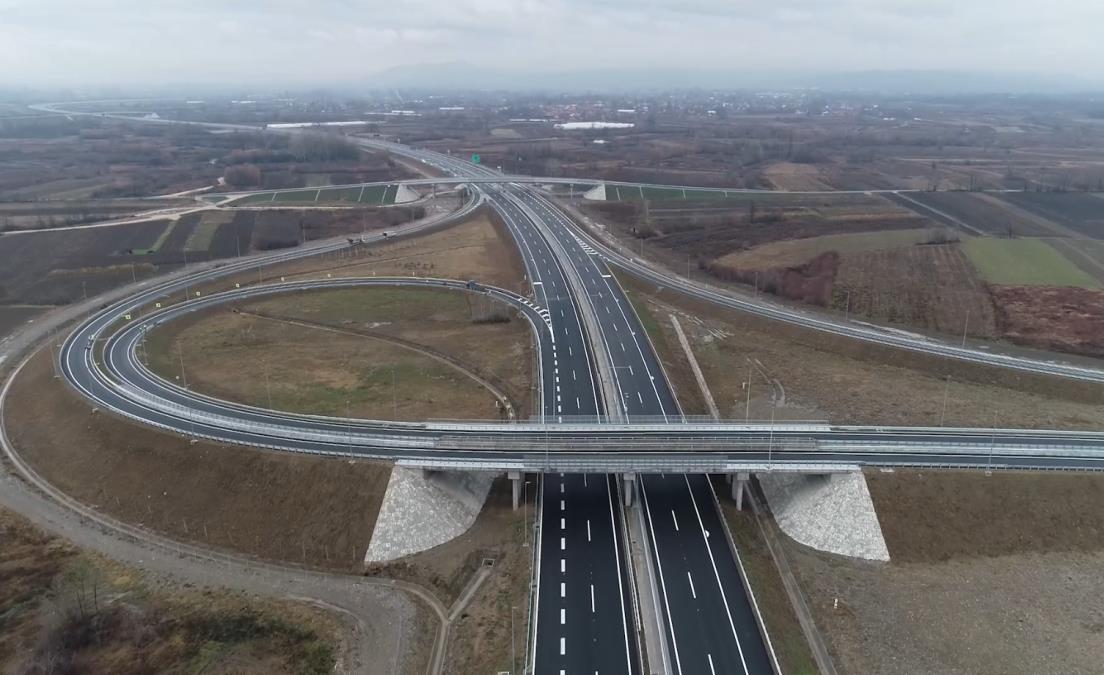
[496,189,773,675]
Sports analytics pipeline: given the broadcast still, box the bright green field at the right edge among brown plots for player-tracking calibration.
[963,236,1101,288]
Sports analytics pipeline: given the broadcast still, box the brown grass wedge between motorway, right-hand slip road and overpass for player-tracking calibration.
[619,275,1104,429]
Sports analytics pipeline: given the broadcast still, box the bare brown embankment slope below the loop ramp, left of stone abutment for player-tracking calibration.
[6,350,391,569]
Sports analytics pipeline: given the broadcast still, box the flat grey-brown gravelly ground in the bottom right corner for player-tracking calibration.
[789,544,1104,675]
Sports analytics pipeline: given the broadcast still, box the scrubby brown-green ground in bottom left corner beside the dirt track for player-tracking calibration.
[0,509,336,675]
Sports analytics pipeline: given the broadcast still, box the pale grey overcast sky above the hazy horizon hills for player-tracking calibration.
[0,0,1104,85]
